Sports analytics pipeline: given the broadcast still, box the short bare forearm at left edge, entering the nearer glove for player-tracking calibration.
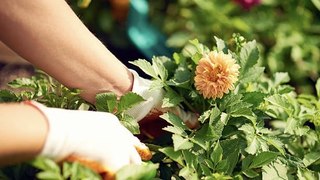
[0,103,48,165]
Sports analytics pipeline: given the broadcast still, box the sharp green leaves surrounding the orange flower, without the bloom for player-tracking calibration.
[129,35,319,179]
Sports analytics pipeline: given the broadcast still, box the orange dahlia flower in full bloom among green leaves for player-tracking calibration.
[194,51,240,99]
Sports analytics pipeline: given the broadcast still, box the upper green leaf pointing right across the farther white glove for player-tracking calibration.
[117,92,144,113]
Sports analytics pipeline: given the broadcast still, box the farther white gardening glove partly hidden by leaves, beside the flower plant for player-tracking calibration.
[127,70,199,129]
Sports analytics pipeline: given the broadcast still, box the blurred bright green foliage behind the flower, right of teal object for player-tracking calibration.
[148,0,320,92]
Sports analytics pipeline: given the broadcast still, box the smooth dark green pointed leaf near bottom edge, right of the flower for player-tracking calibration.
[249,151,278,168]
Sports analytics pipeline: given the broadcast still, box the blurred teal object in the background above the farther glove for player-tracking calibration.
[127,0,173,60]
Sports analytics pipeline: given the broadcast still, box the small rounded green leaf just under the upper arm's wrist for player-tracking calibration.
[96,92,117,113]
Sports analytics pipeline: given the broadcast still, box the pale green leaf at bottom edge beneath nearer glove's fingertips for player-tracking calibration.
[116,163,159,180]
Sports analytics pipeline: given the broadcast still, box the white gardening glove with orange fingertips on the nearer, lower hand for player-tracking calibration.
[23,101,148,177]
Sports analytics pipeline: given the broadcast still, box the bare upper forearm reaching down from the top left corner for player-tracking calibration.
[0,0,132,101]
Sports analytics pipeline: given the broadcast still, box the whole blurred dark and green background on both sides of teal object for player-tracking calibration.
[70,0,320,93]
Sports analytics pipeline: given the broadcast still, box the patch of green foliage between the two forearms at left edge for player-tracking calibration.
[0,72,88,109]
